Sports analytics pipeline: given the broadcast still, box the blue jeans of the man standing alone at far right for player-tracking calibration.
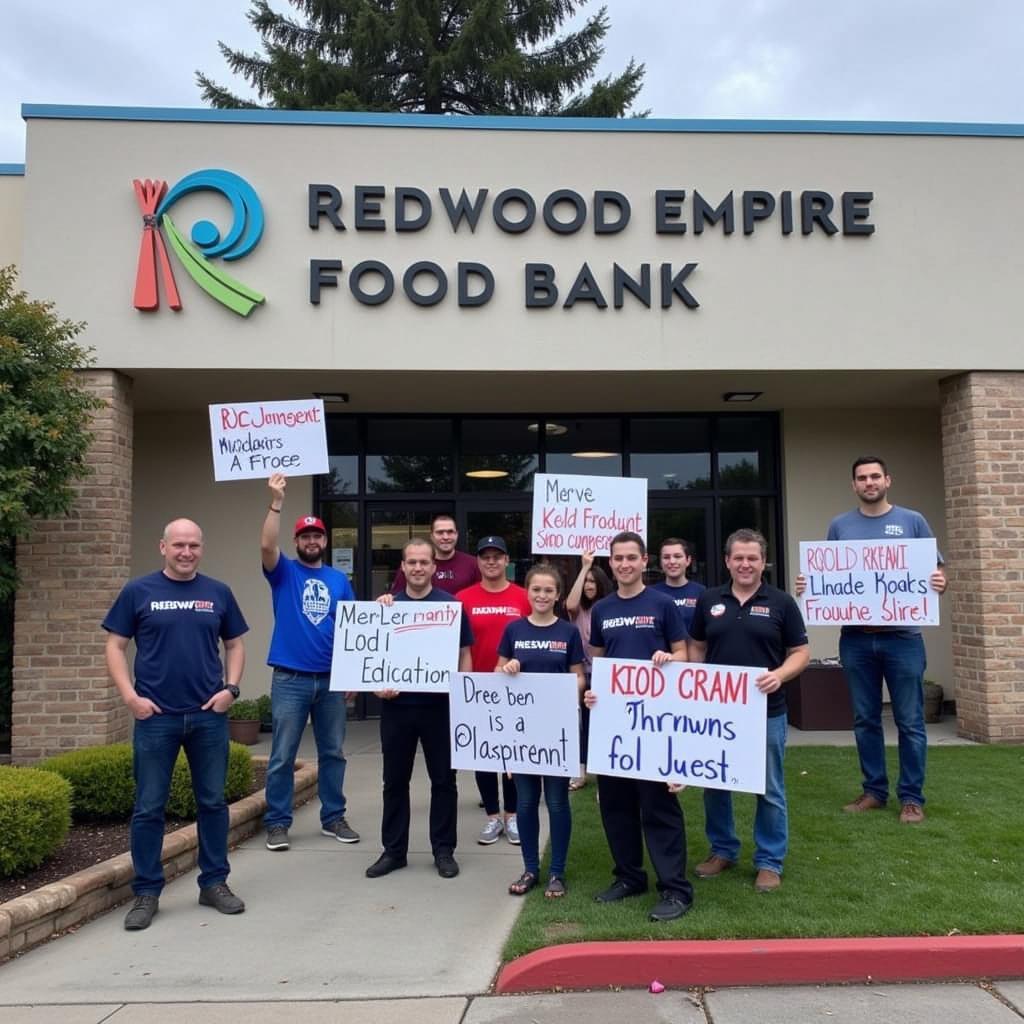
[839,631,928,806]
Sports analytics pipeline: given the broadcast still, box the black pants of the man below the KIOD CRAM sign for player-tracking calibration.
[597,775,693,903]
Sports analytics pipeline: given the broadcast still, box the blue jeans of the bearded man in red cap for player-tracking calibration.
[263,669,345,828]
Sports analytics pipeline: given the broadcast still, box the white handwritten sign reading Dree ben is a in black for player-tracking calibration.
[450,672,580,778]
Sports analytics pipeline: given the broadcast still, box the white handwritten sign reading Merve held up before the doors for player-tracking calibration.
[530,473,647,555]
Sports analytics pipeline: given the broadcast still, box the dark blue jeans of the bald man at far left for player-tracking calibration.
[131,711,230,896]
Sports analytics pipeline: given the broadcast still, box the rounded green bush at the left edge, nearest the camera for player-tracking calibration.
[0,765,71,878]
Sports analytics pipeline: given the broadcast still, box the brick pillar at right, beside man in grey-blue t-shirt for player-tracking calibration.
[941,372,1024,742]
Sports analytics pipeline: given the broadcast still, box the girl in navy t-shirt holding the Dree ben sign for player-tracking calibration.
[498,562,585,899]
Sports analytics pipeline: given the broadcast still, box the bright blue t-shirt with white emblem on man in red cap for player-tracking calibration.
[263,555,355,673]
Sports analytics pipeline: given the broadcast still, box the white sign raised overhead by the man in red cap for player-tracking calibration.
[210,398,330,480]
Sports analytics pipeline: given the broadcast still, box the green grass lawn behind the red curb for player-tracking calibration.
[504,746,1024,959]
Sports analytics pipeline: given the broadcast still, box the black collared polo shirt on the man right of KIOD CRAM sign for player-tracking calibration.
[690,583,807,718]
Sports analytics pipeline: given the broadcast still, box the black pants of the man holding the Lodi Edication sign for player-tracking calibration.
[381,698,459,858]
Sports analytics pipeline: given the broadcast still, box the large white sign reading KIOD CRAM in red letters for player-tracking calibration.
[587,657,767,794]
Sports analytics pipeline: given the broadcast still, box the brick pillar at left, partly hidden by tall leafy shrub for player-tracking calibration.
[11,370,132,764]
